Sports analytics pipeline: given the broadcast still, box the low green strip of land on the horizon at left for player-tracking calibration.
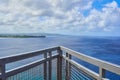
[0,34,46,38]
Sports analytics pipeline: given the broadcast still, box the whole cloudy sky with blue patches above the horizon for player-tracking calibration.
[0,0,120,36]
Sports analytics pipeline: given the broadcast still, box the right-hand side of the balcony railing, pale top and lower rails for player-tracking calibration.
[60,46,120,80]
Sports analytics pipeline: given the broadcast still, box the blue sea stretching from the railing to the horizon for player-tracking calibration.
[0,36,120,80]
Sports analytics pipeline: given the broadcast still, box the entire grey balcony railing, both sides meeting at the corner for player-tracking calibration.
[0,46,120,80]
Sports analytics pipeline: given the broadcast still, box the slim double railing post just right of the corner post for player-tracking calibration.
[66,53,71,80]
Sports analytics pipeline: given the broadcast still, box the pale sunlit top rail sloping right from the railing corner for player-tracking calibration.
[60,46,120,75]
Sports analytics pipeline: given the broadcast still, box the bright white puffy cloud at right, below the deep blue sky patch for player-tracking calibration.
[75,1,120,31]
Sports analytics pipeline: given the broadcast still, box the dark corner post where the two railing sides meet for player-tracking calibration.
[57,49,62,80]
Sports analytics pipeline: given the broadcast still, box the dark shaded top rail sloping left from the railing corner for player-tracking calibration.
[0,47,59,64]
